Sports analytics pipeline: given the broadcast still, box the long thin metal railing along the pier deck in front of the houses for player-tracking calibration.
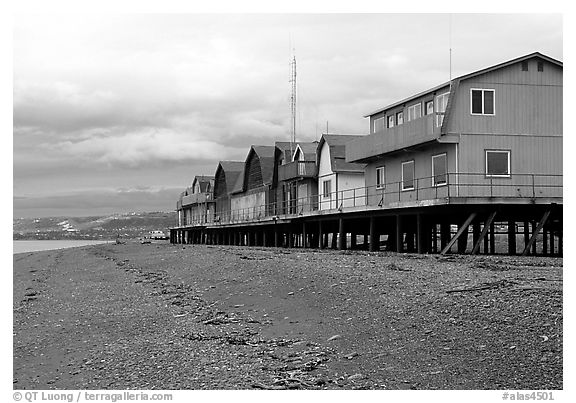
[178,173,563,229]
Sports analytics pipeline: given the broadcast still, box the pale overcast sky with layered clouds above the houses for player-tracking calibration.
[13,14,563,217]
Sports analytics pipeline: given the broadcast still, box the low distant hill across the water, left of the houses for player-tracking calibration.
[12,212,177,240]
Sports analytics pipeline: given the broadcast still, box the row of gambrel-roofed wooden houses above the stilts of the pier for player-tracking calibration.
[177,53,563,256]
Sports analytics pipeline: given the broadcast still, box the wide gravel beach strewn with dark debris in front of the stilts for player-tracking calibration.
[13,242,563,390]
